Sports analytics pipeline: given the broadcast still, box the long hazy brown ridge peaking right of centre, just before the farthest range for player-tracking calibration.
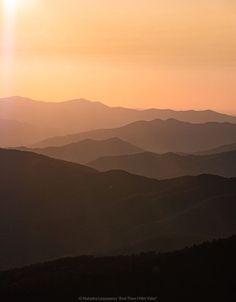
[36,120,236,153]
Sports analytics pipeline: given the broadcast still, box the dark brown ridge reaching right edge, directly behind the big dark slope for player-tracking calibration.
[88,151,236,179]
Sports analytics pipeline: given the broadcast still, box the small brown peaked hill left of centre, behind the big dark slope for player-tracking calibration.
[20,138,143,164]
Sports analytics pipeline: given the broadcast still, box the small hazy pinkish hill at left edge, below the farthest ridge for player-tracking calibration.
[0,119,54,147]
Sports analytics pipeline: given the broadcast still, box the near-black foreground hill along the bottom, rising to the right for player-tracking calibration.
[0,236,236,302]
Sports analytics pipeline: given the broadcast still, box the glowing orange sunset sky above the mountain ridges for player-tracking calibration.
[0,0,236,114]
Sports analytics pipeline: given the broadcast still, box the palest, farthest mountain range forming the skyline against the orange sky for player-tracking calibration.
[0,97,236,146]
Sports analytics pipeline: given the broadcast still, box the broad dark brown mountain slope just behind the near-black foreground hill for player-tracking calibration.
[0,150,236,268]
